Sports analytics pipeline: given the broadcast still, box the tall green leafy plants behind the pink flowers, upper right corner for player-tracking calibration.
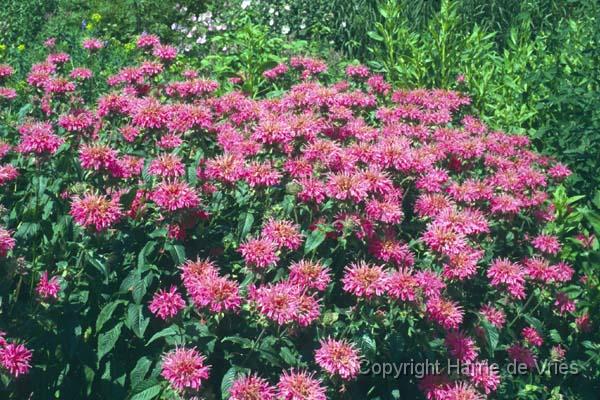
[360,0,600,194]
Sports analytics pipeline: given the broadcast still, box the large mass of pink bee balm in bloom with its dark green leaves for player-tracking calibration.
[0,34,594,400]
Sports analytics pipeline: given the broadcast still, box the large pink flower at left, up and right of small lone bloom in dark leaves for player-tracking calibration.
[70,194,123,231]
